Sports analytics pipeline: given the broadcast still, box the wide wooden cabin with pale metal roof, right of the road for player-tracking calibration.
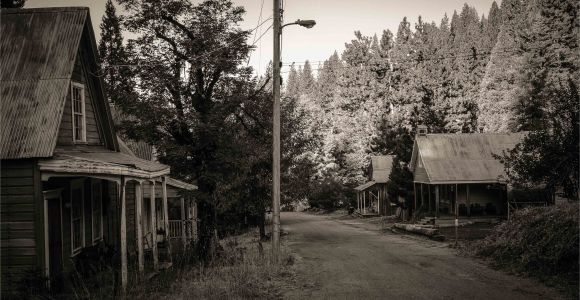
[410,127,523,219]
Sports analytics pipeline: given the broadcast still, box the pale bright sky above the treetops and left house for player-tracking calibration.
[25,0,501,74]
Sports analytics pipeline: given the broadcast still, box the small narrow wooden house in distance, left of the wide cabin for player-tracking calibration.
[355,155,393,216]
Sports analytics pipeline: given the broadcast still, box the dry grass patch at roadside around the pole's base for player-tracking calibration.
[140,232,293,299]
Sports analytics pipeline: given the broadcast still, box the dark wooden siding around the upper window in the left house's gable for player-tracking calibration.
[57,50,103,146]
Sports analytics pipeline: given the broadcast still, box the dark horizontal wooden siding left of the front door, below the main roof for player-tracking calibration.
[0,160,44,290]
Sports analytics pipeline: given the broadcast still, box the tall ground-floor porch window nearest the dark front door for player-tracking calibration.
[70,181,85,254]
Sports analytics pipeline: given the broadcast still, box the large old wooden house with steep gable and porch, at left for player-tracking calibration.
[0,7,196,292]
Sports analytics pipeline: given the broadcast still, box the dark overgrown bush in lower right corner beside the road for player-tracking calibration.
[474,203,579,291]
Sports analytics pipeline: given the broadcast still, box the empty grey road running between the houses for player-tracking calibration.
[282,213,561,300]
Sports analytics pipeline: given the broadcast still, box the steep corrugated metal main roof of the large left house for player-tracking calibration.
[0,7,88,159]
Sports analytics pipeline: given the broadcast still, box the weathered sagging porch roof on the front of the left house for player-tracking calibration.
[38,150,170,179]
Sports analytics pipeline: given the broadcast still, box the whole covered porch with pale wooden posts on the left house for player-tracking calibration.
[39,153,197,288]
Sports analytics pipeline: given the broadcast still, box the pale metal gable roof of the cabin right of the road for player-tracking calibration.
[410,133,525,183]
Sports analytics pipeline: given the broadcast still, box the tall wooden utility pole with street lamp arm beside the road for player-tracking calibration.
[272,0,316,259]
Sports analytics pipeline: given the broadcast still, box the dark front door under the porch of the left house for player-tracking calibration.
[44,191,63,291]
